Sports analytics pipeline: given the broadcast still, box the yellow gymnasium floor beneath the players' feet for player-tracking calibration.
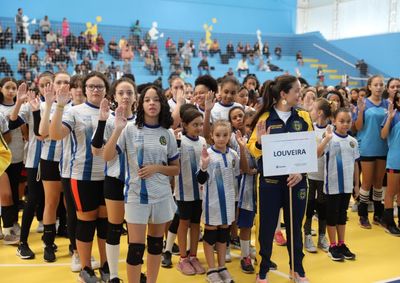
[0,209,400,283]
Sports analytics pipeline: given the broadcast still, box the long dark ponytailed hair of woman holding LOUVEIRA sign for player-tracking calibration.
[251,75,297,129]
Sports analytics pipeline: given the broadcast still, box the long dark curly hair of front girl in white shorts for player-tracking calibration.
[135,85,174,129]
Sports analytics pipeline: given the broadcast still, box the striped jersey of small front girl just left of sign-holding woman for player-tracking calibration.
[202,146,240,226]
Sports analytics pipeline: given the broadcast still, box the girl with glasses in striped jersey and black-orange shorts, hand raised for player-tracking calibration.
[49,72,109,282]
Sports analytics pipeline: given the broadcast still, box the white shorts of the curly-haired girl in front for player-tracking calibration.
[125,196,177,224]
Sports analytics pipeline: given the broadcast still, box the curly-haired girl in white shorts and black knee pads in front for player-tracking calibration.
[103,85,179,283]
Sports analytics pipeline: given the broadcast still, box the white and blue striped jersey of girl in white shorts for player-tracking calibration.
[117,123,179,204]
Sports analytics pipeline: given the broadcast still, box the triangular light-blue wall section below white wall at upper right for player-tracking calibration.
[330,33,400,77]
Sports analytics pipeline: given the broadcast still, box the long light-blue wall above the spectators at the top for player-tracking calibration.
[0,0,297,34]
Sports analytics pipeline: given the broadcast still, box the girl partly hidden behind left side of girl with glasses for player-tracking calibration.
[39,72,71,262]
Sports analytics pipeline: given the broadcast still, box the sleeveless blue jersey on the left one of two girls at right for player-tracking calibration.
[356,99,388,156]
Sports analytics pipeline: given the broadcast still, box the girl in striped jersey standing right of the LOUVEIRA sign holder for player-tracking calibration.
[318,108,360,261]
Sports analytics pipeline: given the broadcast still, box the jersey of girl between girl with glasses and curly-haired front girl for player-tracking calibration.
[104,112,135,182]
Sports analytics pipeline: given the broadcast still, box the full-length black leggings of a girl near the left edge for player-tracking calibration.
[20,168,44,243]
